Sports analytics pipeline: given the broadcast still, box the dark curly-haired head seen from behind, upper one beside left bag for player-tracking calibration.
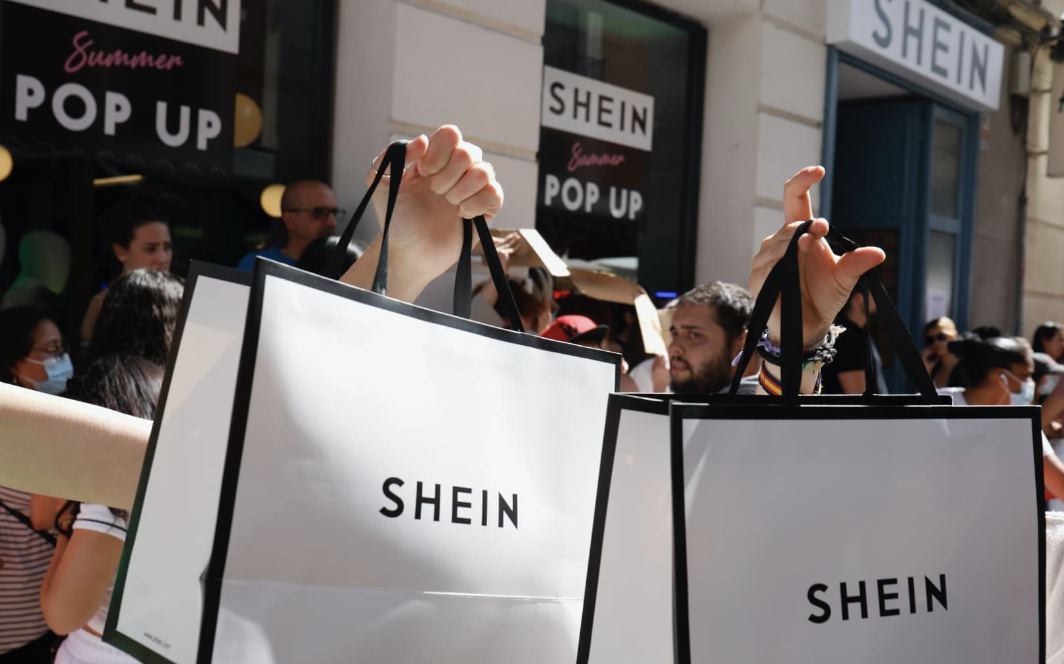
[88,268,185,366]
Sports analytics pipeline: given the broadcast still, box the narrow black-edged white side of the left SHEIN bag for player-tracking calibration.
[103,261,251,664]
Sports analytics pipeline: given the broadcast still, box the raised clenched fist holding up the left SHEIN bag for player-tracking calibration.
[343,125,503,301]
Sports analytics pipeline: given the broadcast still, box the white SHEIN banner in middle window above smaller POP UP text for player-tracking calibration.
[541,67,654,152]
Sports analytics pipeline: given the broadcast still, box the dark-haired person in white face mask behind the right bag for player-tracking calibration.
[938,335,1064,506]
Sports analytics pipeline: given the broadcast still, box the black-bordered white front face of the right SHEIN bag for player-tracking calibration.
[671,403,1045,664]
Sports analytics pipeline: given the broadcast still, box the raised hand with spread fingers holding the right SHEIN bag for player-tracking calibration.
[750,166,886,348]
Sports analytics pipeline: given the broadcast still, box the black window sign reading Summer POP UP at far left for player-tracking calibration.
[0,2,236,172]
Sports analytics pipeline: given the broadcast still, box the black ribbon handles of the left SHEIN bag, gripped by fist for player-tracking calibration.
[325,140,525,332]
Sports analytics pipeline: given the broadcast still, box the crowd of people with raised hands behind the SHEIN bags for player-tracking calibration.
[0,128,1064,664]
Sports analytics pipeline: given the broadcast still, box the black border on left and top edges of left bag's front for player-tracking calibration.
[196,258,620,664]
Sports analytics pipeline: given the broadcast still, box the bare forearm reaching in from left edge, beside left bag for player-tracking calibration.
[0,384,151,509]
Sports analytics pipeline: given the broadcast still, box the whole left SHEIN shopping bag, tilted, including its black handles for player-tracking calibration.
[105,141,619,664]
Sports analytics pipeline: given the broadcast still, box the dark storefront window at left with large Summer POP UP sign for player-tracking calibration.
[0,0,335,341]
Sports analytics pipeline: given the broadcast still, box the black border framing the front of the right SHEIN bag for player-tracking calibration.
[669,402,1046,664]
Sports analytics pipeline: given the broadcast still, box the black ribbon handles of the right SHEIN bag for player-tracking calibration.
[731,220,940,404]
